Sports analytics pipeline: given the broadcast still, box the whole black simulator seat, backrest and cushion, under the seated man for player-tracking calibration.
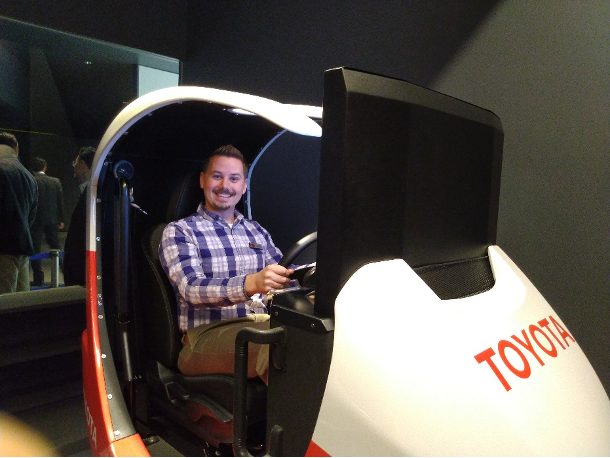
[138,173,267,447]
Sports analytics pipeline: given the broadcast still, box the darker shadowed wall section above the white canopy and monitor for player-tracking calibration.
[183,0,497,100]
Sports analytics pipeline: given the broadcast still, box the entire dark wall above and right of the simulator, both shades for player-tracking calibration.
[0,0,610,398]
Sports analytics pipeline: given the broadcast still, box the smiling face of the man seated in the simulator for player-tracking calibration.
[199,156,248,223]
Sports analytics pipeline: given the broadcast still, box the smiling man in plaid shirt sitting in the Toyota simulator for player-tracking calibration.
[159,145,294,383]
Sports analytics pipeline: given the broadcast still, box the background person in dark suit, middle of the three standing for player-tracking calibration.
[31,156,64,286]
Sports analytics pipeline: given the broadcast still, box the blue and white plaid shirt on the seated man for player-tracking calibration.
[159,204,282,332]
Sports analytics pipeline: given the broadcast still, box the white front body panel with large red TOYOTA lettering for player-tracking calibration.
[313,246,610,456]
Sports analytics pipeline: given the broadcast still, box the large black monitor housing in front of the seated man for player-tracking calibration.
[316,68,504,316]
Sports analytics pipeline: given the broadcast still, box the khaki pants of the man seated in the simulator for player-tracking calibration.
[178,313,270,383]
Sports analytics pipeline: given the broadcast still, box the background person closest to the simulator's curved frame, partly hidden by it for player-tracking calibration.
[64,146,95,286]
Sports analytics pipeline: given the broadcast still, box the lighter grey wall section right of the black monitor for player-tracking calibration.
[432,0,610,398]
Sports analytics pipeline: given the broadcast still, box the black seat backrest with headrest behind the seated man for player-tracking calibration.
[138,172,203,369]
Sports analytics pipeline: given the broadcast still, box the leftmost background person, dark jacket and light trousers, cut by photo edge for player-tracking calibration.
[0,132,38,294]
